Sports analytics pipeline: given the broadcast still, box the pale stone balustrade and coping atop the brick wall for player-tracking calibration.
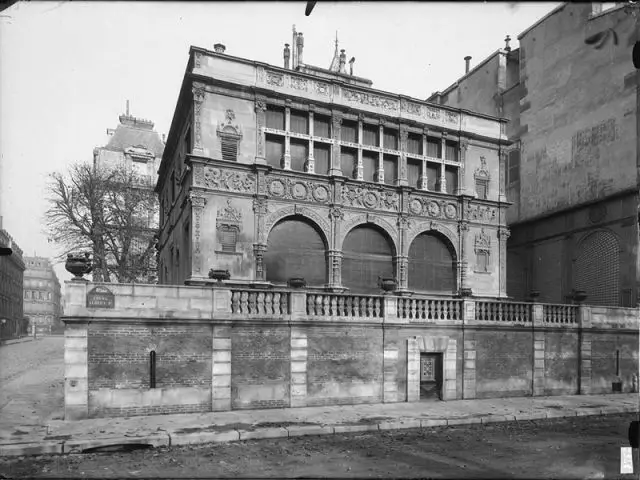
[62,281,640,332]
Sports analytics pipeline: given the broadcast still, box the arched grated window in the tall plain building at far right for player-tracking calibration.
[574,230,620,307]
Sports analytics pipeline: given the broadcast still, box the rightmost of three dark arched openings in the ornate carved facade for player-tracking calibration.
[408,232,456,293]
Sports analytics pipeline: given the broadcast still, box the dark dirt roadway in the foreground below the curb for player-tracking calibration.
[0,414,638,479]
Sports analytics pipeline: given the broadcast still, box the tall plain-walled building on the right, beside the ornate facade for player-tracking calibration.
[429,3,640,306]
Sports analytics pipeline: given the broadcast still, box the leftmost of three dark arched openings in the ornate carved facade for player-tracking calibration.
[263,217,327,286]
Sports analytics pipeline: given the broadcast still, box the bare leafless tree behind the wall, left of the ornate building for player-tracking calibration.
[44,163,158,283]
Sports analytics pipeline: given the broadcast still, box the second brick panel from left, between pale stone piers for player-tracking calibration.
[231,326,291,409]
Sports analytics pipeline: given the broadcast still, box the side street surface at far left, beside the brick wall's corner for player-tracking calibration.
[0,336,64,428]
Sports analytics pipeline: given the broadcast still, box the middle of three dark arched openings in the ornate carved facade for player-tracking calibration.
[342,225,394,293]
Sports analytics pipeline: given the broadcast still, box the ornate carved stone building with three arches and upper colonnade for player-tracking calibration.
[156,33,508,297]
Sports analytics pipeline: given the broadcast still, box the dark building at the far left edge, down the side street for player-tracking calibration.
[0,217,27,340]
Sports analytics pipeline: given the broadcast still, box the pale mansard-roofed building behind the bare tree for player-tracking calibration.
[93,105,164,283]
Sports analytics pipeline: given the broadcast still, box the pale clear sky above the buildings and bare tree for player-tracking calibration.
[0,1,559,289]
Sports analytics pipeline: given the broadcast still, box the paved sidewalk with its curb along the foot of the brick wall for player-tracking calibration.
[0,393,639,456]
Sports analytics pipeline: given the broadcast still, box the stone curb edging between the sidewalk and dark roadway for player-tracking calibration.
[0,406,638,457]
